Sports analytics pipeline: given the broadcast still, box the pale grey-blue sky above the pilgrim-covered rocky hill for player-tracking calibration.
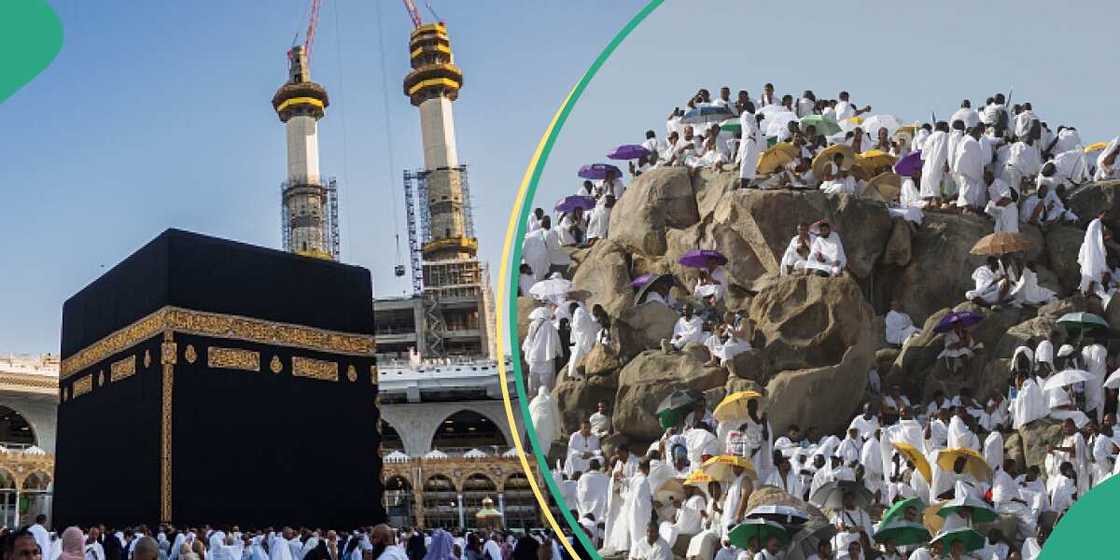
[534,0,1120,227]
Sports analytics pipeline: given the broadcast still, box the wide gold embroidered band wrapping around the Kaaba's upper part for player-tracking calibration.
[59,306,375,380]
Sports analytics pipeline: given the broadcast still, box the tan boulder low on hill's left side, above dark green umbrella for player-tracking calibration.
[612,345,727,441]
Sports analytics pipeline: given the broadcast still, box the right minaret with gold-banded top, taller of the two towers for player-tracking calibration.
[404,22,478,261]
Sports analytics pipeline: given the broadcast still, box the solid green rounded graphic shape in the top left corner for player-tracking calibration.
[0,0,63,103]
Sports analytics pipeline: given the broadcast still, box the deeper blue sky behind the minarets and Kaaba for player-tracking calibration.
[0,0,643,353]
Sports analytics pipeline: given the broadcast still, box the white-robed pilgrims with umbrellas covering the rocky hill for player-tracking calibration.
[519,84,1120,560]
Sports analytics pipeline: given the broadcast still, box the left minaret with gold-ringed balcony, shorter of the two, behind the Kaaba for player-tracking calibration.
[272,46,333,259]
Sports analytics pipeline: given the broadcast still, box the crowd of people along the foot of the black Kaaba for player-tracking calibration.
[0,515,586,560]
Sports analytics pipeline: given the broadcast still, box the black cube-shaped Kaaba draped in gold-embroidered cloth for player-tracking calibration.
[53,230,385,529]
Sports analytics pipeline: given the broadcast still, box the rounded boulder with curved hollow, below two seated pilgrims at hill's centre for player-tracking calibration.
[750,274,878,373]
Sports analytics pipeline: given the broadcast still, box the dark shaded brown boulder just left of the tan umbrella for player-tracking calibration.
[884,212,991,320]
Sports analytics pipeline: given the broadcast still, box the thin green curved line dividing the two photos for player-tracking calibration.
[505,0,664,559]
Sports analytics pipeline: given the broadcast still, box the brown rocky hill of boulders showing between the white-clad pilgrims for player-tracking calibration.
[519,168,1120,463]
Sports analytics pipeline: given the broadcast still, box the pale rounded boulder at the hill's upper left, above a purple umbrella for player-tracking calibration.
[607,167,700,255]
